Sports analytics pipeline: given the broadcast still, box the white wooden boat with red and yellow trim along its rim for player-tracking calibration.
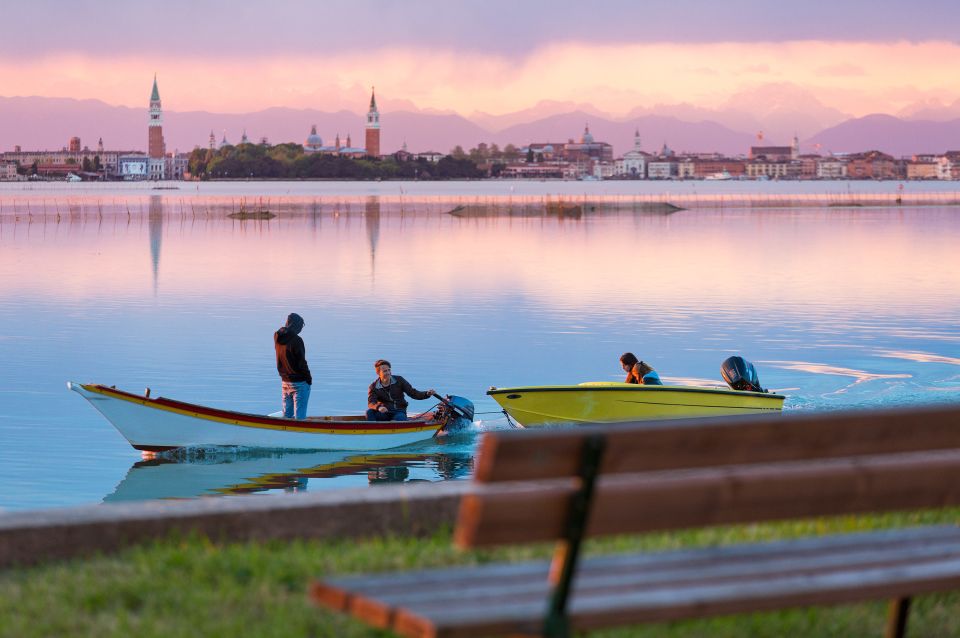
[67,382,473,452]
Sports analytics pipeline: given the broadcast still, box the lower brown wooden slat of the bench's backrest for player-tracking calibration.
[455,450,960,547]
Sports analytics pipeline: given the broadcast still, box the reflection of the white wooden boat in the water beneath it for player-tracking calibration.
[103,450,473,503]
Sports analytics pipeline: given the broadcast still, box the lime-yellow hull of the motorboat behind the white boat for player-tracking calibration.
[487,383,784,427]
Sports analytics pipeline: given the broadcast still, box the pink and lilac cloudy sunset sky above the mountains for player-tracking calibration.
[0,0,960,117]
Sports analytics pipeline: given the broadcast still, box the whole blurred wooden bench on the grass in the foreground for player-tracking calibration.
[311,407,960,637]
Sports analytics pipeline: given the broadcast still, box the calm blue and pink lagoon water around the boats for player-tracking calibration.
[0,183,960,509]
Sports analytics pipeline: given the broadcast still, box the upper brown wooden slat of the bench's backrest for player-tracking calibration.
[475,406,960,482]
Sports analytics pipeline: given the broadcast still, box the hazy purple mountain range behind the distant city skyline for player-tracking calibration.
[0,91,960,157]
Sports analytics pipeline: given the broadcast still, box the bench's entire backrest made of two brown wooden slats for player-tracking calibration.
[455,406,960,547]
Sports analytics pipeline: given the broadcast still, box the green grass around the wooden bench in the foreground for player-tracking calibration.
[0,509,960,638]
